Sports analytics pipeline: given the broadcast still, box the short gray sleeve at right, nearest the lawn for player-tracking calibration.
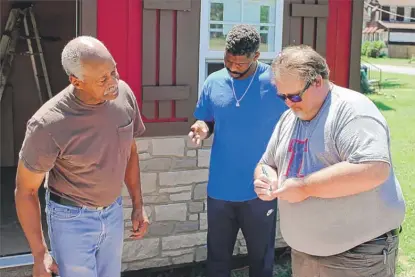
[335,116,390,164]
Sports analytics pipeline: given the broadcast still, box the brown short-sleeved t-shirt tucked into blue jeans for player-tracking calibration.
[19,78,145,206]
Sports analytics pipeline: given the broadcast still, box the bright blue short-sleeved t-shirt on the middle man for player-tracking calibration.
[194,62,287,201]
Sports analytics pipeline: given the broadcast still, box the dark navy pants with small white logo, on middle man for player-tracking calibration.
[207,198,277,277]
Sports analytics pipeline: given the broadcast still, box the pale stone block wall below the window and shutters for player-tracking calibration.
[123,137,285,271]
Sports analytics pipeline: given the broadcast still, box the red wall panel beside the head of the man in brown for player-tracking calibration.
[96,0,143,104]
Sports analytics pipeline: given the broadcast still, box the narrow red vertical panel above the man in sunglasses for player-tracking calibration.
[326,0,353,87]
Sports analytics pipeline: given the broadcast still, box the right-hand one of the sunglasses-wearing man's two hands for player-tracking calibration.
[272,178,310,203]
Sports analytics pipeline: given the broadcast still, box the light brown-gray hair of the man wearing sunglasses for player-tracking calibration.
[272,45,330,83]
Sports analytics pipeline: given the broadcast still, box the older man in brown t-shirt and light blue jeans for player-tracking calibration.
[16,37,148,277]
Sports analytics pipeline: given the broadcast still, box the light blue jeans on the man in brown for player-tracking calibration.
[46,192,124,277]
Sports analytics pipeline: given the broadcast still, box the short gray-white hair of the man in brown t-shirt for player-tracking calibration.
[61,36,112,80]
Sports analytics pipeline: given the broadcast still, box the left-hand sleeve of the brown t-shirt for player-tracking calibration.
[19,120,60,173]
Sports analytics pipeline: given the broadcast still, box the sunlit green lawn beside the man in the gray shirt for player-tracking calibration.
[369,73,415,277]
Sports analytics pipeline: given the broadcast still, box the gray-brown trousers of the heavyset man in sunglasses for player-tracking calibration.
[291,231,399,277]
